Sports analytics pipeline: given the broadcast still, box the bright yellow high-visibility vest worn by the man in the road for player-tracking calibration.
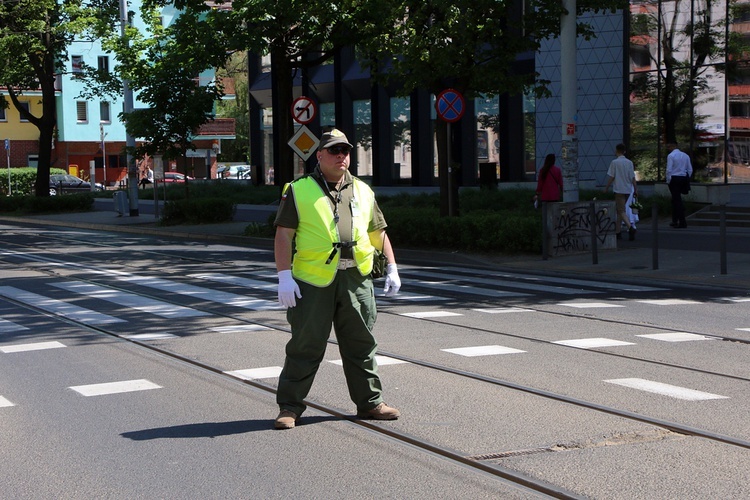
[284,176,375,287]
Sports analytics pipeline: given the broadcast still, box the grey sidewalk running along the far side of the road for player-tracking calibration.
[0,204,750,294]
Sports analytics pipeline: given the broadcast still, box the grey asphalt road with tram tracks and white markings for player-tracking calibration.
[0,222,750,499]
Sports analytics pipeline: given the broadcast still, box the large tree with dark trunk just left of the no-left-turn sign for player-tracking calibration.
[118,0,368,188]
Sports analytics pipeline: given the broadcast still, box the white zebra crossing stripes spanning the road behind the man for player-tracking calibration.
[0,264,744,333]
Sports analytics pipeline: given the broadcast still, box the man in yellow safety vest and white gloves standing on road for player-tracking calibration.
[274,129,401,429]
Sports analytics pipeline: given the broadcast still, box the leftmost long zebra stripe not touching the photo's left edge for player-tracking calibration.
[52,281,211,318]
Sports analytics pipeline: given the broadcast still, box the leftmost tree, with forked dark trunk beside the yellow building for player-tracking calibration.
[0,0,117,196]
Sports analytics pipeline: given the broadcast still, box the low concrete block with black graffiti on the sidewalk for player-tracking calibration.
[549,202,616,255]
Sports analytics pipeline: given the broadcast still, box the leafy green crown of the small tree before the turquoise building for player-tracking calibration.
[84,1,226,164]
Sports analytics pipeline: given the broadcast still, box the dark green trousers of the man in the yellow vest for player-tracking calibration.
[276,268,383,415]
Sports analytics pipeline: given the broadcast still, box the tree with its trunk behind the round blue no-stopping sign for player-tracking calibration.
[361,0,622,216]
